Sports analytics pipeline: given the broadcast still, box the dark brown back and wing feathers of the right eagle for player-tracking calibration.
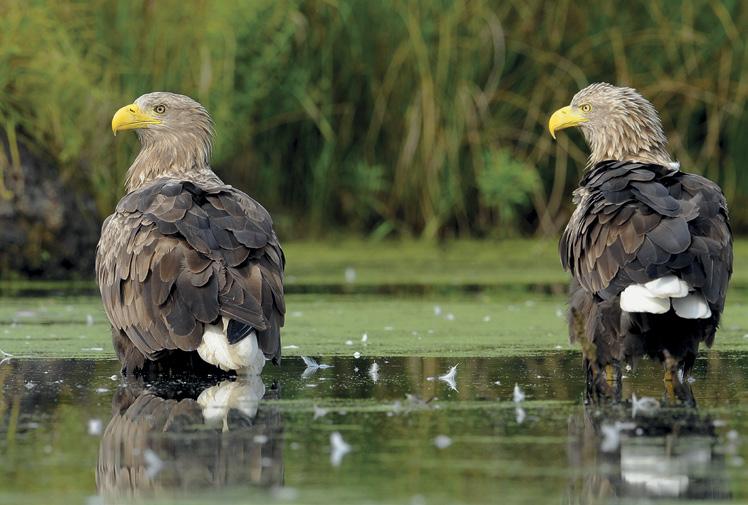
[559,161,732,311]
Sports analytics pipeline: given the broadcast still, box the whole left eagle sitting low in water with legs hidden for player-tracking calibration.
[96,92,286,374]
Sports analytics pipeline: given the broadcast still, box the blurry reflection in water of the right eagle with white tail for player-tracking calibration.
[567,406,731,503]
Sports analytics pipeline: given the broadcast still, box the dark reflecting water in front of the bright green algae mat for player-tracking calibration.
[0,351,748,504]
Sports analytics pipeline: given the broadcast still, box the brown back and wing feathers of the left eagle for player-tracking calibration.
[97,180,285,360]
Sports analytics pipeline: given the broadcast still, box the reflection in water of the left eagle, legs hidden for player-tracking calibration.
[96,376,283,503]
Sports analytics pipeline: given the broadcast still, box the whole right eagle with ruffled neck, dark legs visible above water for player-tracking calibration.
[548,83,733,403]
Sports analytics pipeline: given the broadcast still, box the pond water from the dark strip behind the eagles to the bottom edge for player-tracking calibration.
[0,286,748,505]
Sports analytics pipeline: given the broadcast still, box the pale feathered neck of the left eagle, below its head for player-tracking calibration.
[125,124,221,193]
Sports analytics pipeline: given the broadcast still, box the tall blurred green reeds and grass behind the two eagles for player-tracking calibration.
[0,0,748,278]
